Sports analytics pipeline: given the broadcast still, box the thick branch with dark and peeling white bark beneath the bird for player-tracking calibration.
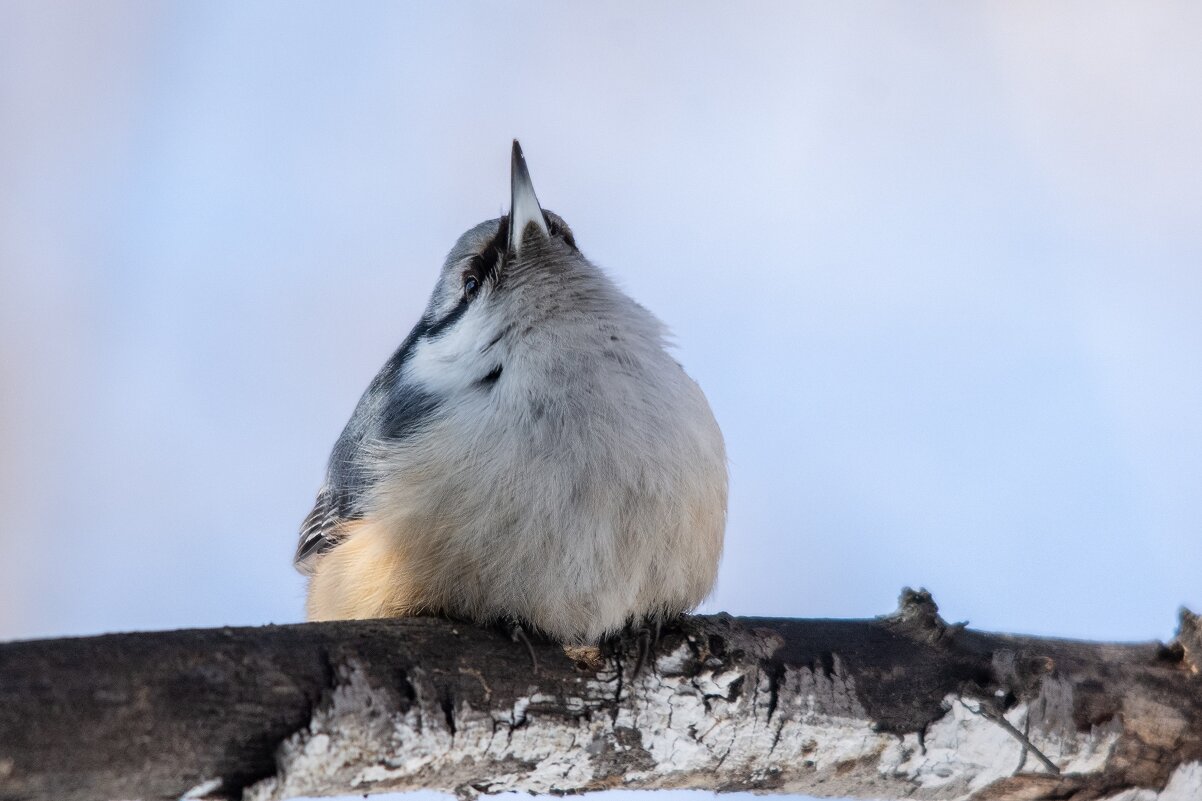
[0,591,1202,801]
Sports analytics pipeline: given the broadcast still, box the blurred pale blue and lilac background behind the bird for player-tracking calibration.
[0,0,1202,793]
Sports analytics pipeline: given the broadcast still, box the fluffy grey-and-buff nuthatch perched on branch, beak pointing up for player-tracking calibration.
[294,140,728,649]
